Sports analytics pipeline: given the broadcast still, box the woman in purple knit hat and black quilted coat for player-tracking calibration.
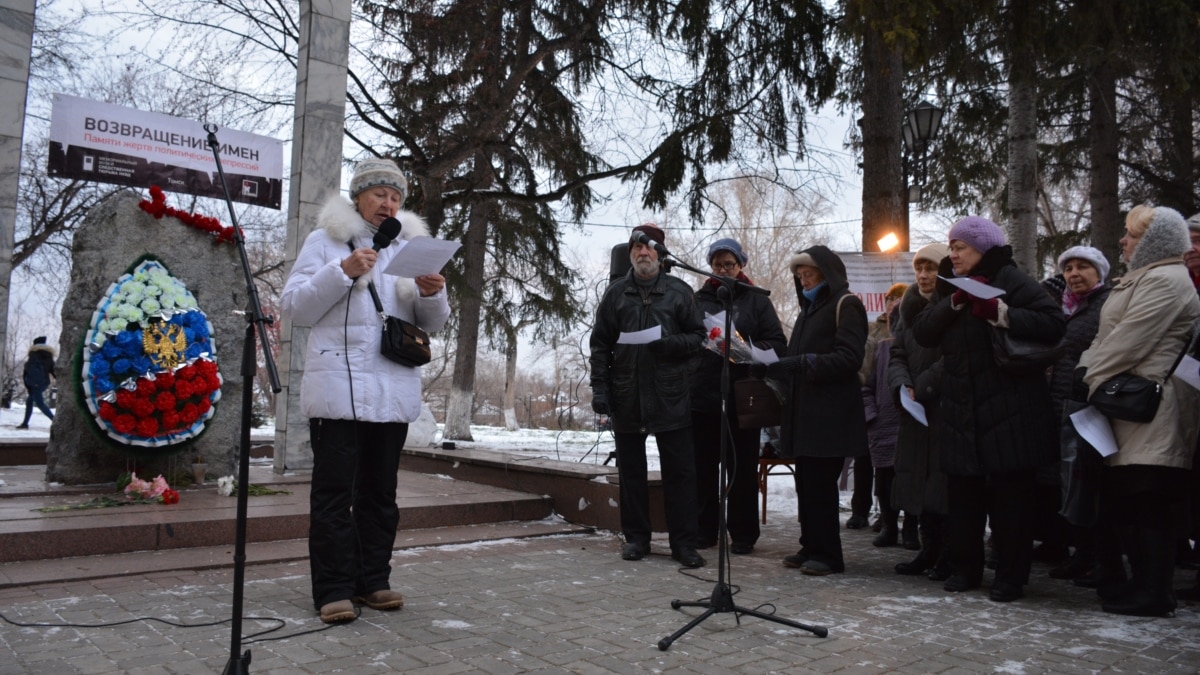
[912,216,1064,602]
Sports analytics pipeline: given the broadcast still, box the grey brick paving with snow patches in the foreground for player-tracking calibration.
[0,518,1200,675]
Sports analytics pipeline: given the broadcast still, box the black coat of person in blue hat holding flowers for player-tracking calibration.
[691,271,787,412]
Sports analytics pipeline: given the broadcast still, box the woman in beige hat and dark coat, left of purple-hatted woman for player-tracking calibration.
[888,243,950,581]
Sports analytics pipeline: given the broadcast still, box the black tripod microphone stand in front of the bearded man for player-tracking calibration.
[655,245,829,651]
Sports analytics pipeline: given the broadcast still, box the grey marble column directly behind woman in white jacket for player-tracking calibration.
[278,0,350,473]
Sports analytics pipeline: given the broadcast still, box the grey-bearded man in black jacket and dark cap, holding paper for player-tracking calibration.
[589,223,704,567]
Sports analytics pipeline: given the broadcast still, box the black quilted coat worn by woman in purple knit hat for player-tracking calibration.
[912,246,1066,476]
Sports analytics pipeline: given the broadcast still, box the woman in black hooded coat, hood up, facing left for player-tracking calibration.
[767,246,868,575]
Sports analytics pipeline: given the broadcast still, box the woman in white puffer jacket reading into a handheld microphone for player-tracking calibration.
[283,159,450,623]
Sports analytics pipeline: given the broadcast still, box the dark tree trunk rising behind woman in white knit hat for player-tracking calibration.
[1087,53,1124,270]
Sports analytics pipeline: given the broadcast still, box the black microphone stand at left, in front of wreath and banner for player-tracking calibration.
[204,124,283,675]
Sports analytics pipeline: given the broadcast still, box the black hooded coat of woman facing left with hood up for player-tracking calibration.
[779,246,868,458]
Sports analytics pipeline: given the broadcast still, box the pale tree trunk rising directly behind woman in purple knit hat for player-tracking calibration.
[1008,42,1040,270]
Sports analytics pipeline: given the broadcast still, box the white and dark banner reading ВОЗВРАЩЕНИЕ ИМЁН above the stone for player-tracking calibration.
[48,94,283,209]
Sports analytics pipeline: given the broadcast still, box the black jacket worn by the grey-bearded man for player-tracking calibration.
[589,270,704,434]
